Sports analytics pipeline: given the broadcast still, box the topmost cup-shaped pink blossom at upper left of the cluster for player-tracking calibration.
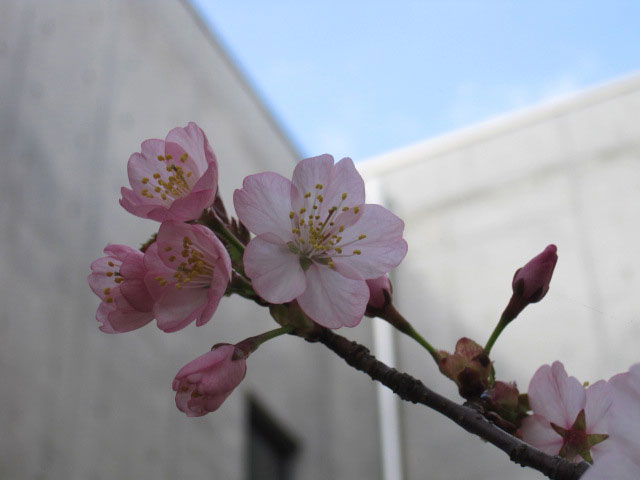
[120,122,218,222]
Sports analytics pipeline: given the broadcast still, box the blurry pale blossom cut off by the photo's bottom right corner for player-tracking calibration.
[582,363,640,480]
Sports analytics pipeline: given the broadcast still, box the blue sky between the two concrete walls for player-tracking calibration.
[192,0,640,161]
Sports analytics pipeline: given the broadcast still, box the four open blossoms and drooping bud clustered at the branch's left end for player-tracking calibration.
[88,123,407,416]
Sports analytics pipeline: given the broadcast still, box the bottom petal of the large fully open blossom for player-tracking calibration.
[298,264,369,328]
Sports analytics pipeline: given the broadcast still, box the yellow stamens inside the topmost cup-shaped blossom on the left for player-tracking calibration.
[140,153,193,201]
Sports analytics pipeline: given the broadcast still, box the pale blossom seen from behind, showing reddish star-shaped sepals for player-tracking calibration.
[520,362,612,463]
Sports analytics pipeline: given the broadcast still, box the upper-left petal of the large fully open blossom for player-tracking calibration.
[233,172,298,242]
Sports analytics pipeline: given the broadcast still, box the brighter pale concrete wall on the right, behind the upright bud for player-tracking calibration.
[360,76,640,480]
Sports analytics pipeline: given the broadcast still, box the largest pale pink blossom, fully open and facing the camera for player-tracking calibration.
[233,155,407,328]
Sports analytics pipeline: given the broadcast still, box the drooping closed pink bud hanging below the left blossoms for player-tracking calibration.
[173,344,247,417]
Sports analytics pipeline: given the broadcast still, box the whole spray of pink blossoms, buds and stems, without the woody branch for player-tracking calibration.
[88,123,640,480]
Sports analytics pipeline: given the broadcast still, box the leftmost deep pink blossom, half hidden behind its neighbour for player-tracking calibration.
[87,245,153,333]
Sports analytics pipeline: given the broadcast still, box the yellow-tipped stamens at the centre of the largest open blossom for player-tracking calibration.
[287,183,367,270]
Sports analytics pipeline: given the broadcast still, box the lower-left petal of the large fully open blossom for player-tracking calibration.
[244,234,306,303]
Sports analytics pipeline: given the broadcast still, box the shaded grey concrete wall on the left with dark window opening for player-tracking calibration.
[0,0,379,480]
